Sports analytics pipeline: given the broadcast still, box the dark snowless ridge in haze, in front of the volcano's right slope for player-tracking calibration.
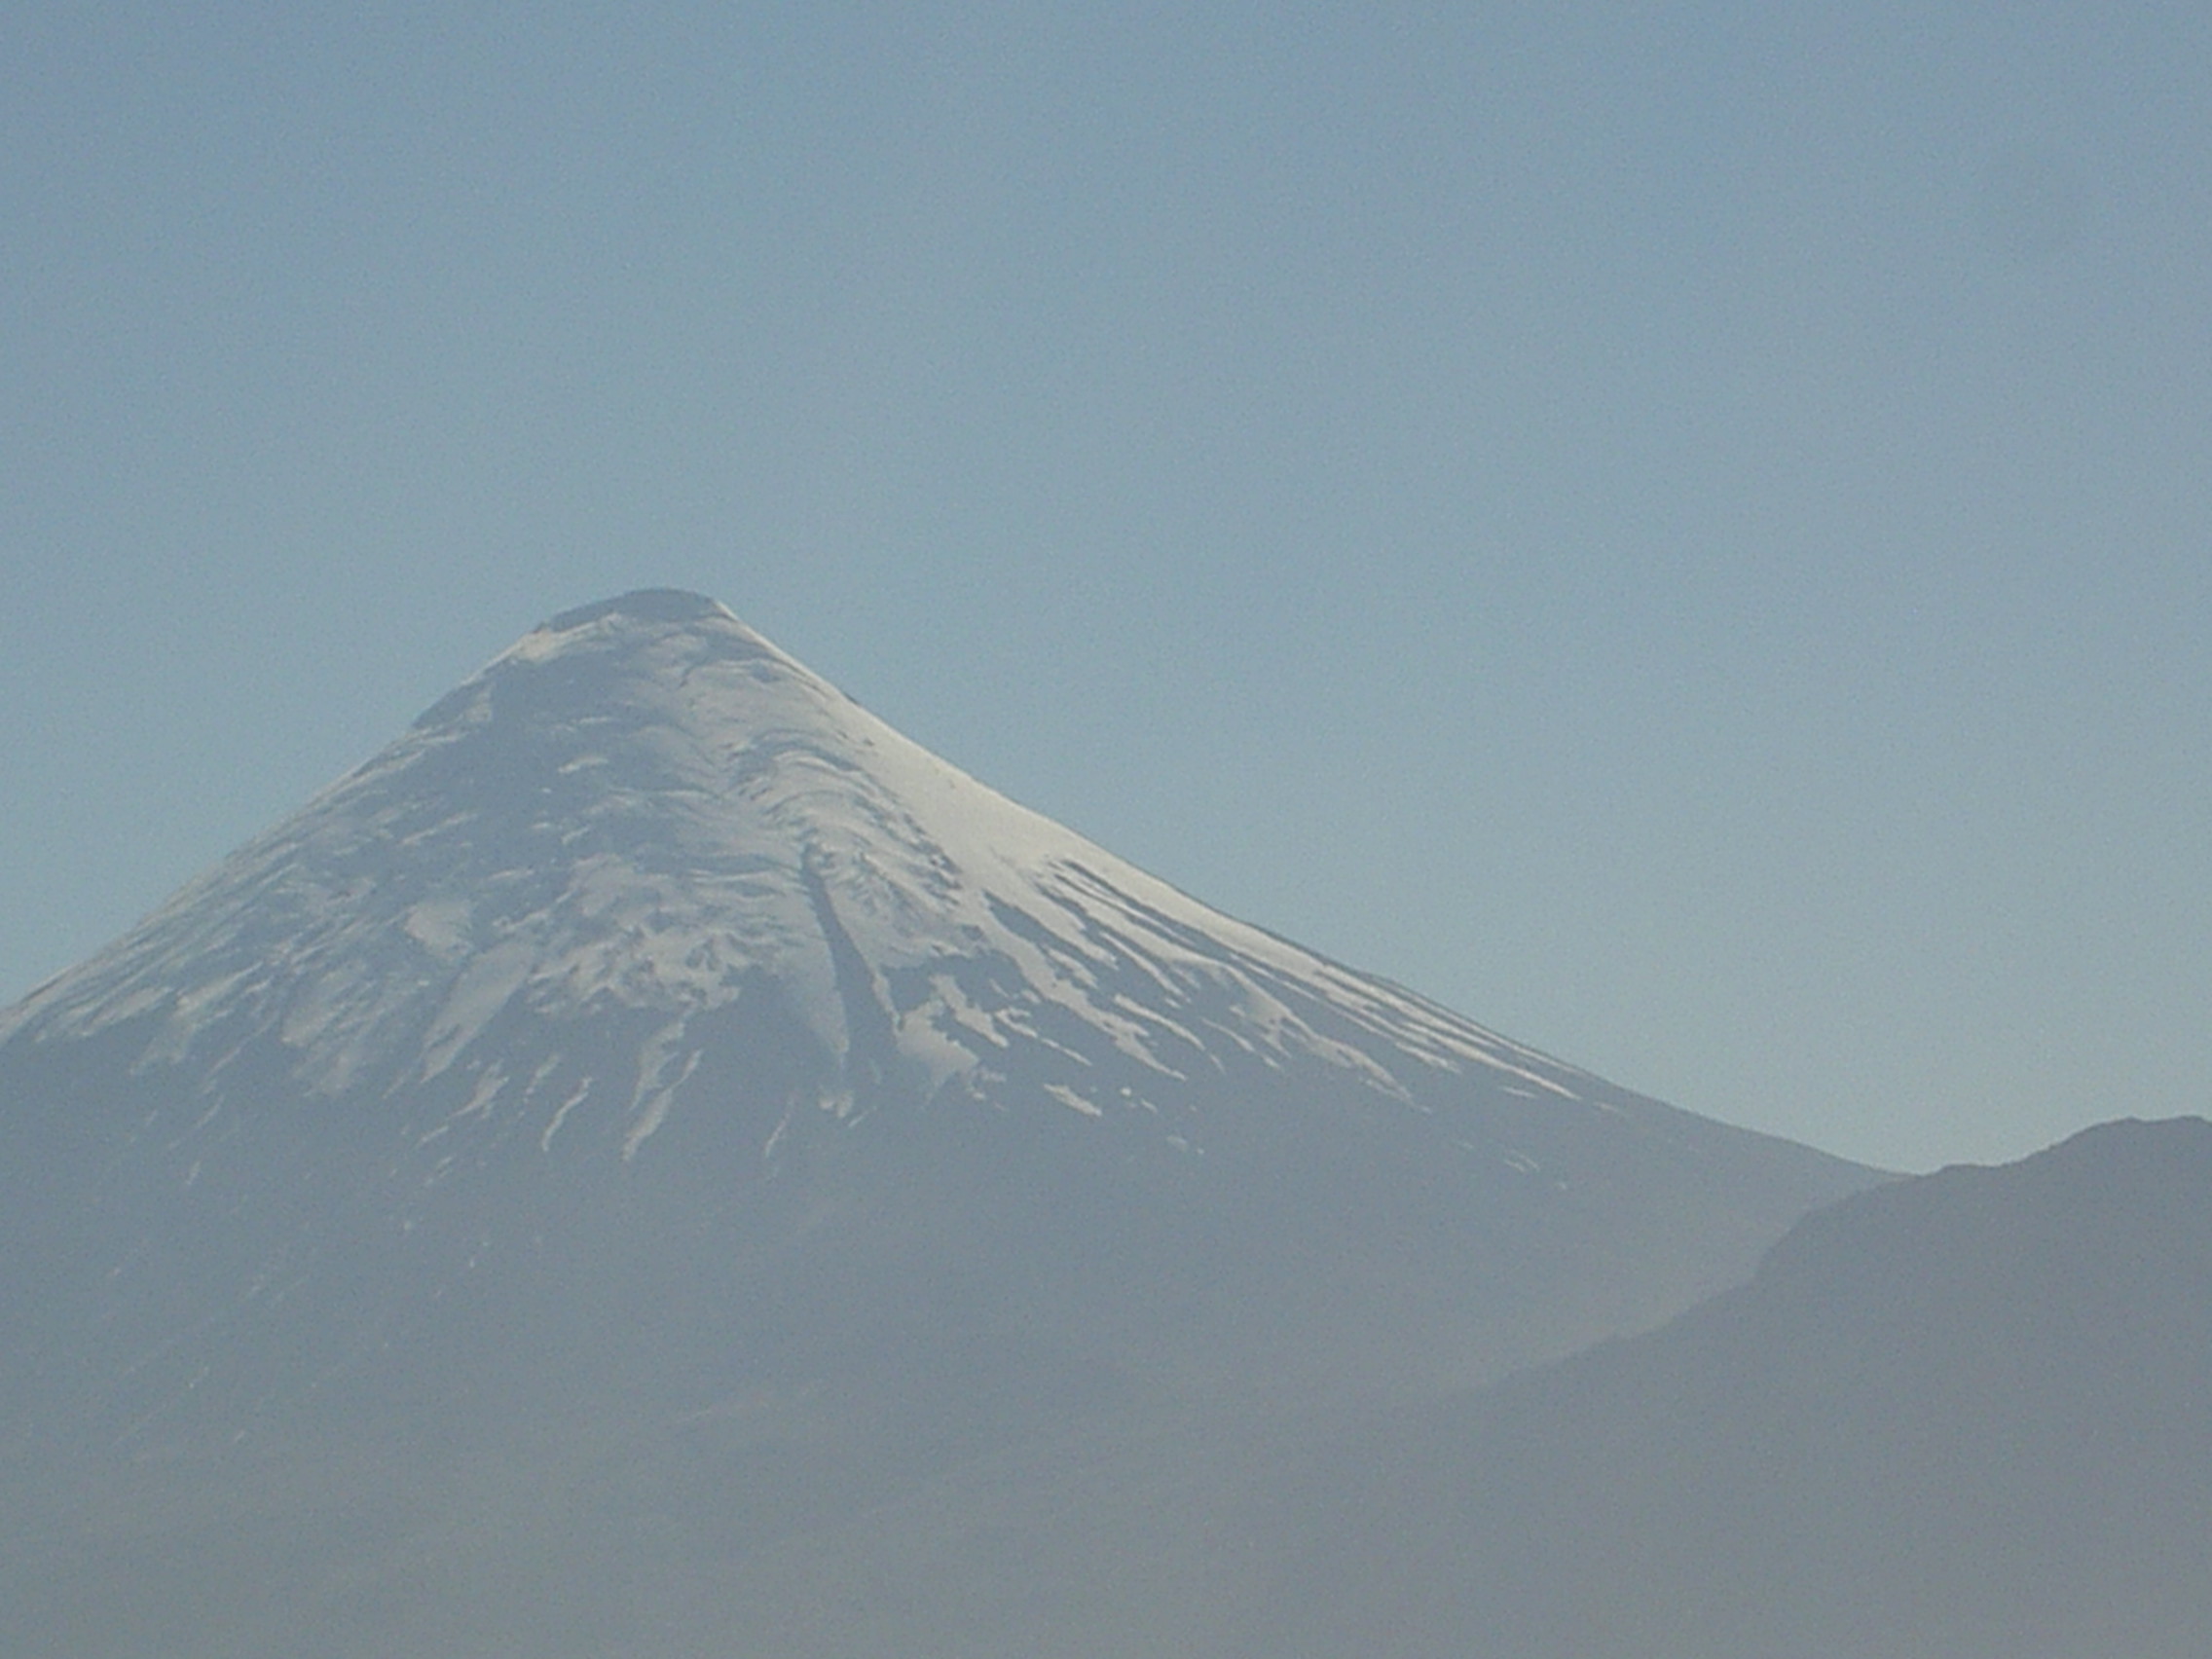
[1245,1117,2212,1659]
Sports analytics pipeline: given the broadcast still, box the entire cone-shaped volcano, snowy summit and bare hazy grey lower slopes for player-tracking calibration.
[0,593,1878,1652]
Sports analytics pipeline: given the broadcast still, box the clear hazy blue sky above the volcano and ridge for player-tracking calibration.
[0,0,2212,1168]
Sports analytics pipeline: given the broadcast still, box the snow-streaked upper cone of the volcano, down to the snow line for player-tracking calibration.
[0,591,1604,1155]
